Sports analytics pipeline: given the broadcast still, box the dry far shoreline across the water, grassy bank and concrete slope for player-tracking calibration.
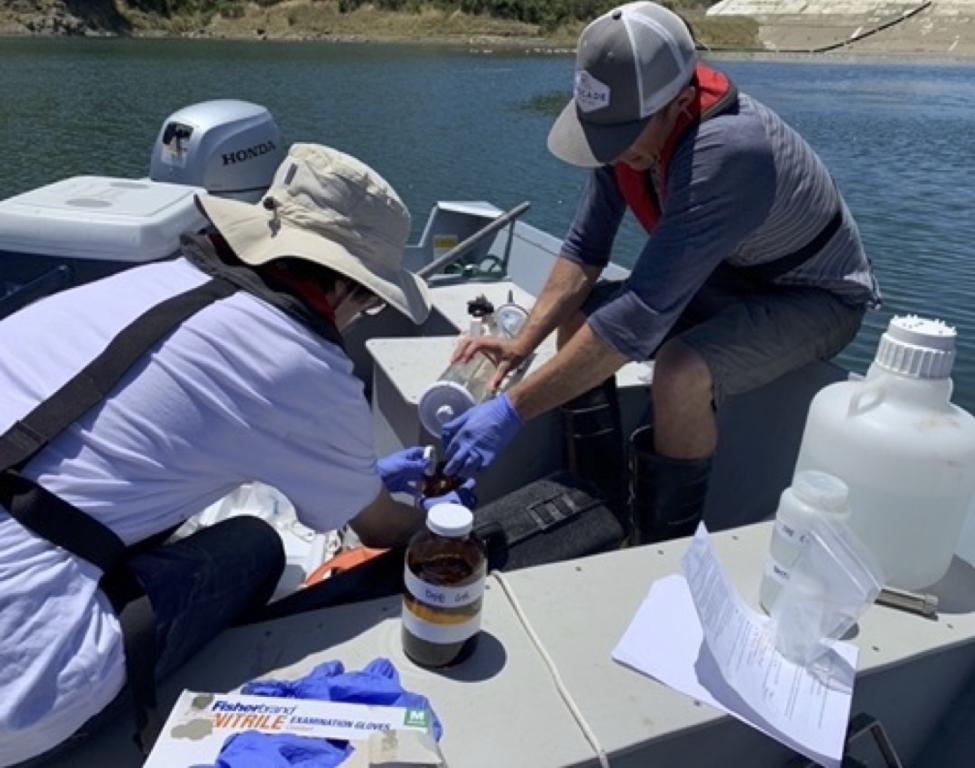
[0,0,975,65]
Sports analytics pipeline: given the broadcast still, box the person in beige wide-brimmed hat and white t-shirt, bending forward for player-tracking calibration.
[0,144,469,766]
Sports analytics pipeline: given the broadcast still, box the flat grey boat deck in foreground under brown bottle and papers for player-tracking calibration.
[49,523,975,768]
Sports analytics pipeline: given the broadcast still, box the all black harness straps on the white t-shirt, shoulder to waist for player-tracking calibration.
[0,278,238,753]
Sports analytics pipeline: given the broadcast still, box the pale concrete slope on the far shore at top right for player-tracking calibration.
[708,0,975,58]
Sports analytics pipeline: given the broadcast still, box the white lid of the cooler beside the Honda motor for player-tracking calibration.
[0,176,207,263]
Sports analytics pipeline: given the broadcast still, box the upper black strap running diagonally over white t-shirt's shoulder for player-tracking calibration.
[0,278,238,471]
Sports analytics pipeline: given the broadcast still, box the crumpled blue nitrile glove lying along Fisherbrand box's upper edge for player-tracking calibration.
[241,658,443,741]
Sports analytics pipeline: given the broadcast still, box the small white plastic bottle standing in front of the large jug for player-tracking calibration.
[759,470,850,613]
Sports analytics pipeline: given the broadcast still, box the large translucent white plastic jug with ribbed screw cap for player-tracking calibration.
[796,316,975,589]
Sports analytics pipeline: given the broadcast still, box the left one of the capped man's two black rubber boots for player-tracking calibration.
[561,376,632,535]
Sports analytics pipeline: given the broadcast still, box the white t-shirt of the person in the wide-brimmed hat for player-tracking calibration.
[0,259,381,766]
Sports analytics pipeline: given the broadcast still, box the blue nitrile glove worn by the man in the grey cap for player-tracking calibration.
[441,394,522,477]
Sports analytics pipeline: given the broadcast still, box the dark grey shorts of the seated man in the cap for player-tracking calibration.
[582,268,864,406]
